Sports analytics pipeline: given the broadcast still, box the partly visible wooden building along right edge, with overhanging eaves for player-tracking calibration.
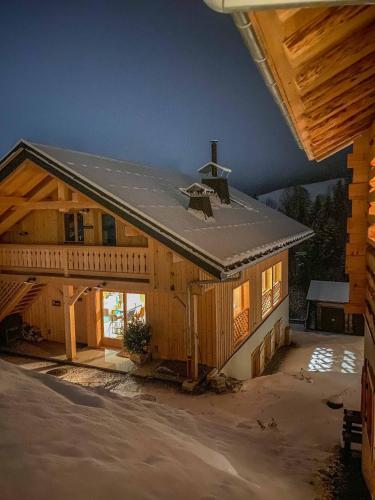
[205,0,375,497]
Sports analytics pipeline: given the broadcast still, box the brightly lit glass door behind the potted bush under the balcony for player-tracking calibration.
[103,291,146,339]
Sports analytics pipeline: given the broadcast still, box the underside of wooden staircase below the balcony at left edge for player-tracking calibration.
[0,281,45,321]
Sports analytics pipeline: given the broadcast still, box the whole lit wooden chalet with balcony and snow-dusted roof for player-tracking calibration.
[0,141,312,379]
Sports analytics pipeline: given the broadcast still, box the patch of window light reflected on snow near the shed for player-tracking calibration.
[308,347,358,373]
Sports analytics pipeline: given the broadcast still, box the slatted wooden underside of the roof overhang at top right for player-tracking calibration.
[247,5,375,161]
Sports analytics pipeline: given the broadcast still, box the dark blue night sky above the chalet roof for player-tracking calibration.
[0,0,346,193]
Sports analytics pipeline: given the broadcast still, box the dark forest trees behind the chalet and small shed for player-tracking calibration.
[266,179,349,320]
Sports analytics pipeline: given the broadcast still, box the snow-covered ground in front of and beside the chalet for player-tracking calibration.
[0,332,363,500]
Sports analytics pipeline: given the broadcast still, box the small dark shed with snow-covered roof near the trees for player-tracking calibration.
[305,280,363,335]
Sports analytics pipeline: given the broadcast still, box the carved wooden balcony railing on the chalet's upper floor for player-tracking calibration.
[0,244,149,276]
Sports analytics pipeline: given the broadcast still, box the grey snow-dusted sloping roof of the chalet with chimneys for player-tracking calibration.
[0,141,313,279]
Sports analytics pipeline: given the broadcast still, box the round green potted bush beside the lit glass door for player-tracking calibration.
[123,317,151,364]
